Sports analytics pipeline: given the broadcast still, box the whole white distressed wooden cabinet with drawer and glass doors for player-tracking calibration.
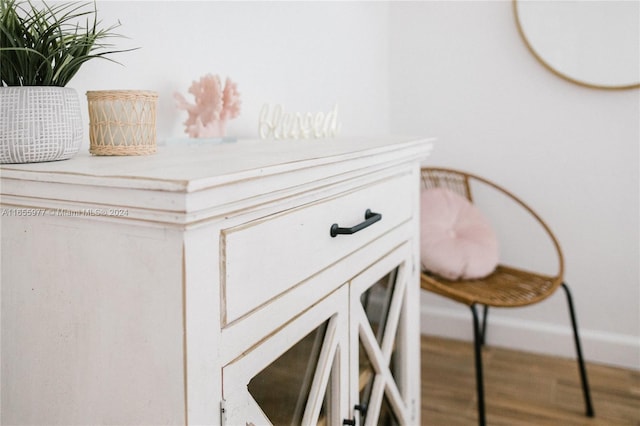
[0,138,431,426]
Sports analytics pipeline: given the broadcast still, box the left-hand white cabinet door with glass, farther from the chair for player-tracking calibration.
[222,286,349,426]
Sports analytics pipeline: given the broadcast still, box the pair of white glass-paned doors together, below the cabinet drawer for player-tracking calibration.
[222,244,419,426]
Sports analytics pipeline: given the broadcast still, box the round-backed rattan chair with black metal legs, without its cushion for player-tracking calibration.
[421,168,594,425]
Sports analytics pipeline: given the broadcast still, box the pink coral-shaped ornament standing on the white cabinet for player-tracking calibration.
[174,74,241,138]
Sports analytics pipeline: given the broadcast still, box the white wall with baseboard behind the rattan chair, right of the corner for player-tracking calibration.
[390,1,640,369]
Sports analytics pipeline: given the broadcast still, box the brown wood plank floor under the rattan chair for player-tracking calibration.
[422,337,640,426]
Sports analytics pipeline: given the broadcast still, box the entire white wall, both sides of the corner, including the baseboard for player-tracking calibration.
[63,1,640,368]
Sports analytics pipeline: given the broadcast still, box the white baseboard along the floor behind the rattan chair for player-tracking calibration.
[420,306,640,370]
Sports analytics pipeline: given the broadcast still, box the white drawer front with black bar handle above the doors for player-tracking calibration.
[220,174,415,325]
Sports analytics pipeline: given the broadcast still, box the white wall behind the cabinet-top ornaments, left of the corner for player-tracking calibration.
[69,1,389,149]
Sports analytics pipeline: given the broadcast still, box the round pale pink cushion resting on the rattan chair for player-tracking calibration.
[420,188,498,280]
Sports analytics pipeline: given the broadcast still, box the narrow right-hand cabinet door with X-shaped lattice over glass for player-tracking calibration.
[349,244,420,426]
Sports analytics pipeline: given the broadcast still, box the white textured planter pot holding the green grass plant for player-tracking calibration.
[0,86,82,164]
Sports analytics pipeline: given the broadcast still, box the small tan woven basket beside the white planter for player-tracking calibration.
[87,90,158,155]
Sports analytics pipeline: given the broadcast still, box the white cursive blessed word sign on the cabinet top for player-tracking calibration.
[258,104,340,139]
